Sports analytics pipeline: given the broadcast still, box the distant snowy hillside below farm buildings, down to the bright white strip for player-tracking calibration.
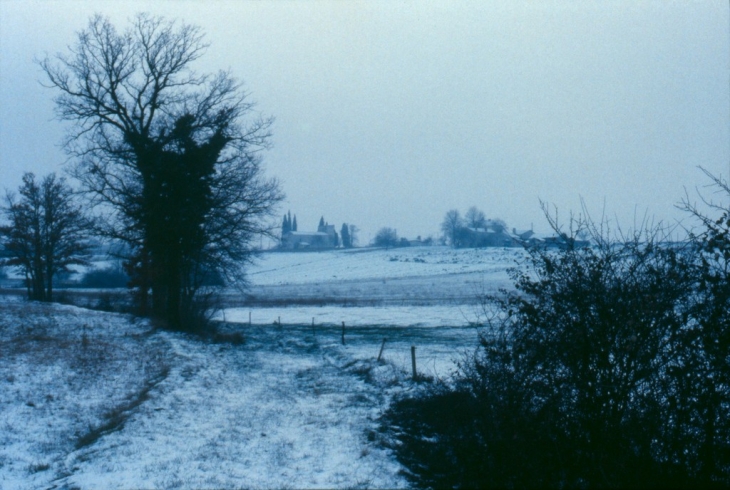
[226,247,524,307]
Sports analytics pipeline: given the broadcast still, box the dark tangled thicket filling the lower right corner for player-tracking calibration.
[383,193,730,488]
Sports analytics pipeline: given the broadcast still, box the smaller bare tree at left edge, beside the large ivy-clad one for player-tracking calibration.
[0,173,89,301]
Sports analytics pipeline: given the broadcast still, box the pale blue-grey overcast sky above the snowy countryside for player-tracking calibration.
[0,0,730,243]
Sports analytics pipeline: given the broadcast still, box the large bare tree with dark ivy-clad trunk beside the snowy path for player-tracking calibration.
[40,14,283,328]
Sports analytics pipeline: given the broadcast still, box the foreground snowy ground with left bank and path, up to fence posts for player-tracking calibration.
[0,292,475,489]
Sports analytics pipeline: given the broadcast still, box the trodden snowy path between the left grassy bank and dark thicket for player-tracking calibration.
[49,327,407,488]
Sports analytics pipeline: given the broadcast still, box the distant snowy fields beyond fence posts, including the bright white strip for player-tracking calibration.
[218,247,524,334]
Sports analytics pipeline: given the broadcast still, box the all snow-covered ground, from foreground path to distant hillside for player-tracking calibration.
[0,247,521,489]
